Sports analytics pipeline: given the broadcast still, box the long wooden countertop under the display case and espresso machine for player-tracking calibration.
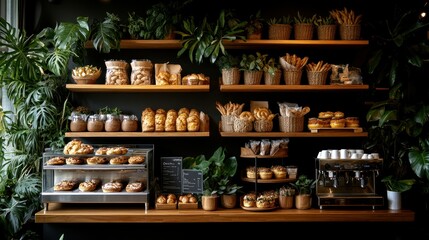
[36,203,415,223]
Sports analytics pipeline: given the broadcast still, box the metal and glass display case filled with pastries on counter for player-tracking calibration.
[41,140,154,212]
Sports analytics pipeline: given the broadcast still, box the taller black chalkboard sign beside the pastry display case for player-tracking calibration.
[161,157,182,194]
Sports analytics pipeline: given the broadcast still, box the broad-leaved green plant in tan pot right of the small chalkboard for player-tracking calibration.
[183,144,239,210]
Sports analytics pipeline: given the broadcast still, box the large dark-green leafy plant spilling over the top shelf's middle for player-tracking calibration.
[176,10,247,64]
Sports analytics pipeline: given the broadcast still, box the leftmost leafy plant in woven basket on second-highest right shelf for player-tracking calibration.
[216,54,240,85]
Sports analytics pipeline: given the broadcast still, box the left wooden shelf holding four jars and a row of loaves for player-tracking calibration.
[65,132,210,138]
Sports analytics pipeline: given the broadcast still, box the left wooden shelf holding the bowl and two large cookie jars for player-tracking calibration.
[66,83,210,93]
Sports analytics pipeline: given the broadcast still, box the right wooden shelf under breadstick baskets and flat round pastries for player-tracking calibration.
[220,131,368,138]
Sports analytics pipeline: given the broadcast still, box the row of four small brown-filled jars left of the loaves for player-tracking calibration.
[70,114,138,132]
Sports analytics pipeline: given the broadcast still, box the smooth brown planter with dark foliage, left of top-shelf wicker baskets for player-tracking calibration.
[267,15,293,40]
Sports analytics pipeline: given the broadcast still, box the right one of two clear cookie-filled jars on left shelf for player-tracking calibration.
[131,59,153,85]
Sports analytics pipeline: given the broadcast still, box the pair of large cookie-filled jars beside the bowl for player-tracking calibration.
[105,59,153,85]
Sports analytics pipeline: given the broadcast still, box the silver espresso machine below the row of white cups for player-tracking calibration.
[316,158,384,209]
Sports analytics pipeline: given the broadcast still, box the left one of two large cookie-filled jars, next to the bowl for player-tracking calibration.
[105,60,129,85]
